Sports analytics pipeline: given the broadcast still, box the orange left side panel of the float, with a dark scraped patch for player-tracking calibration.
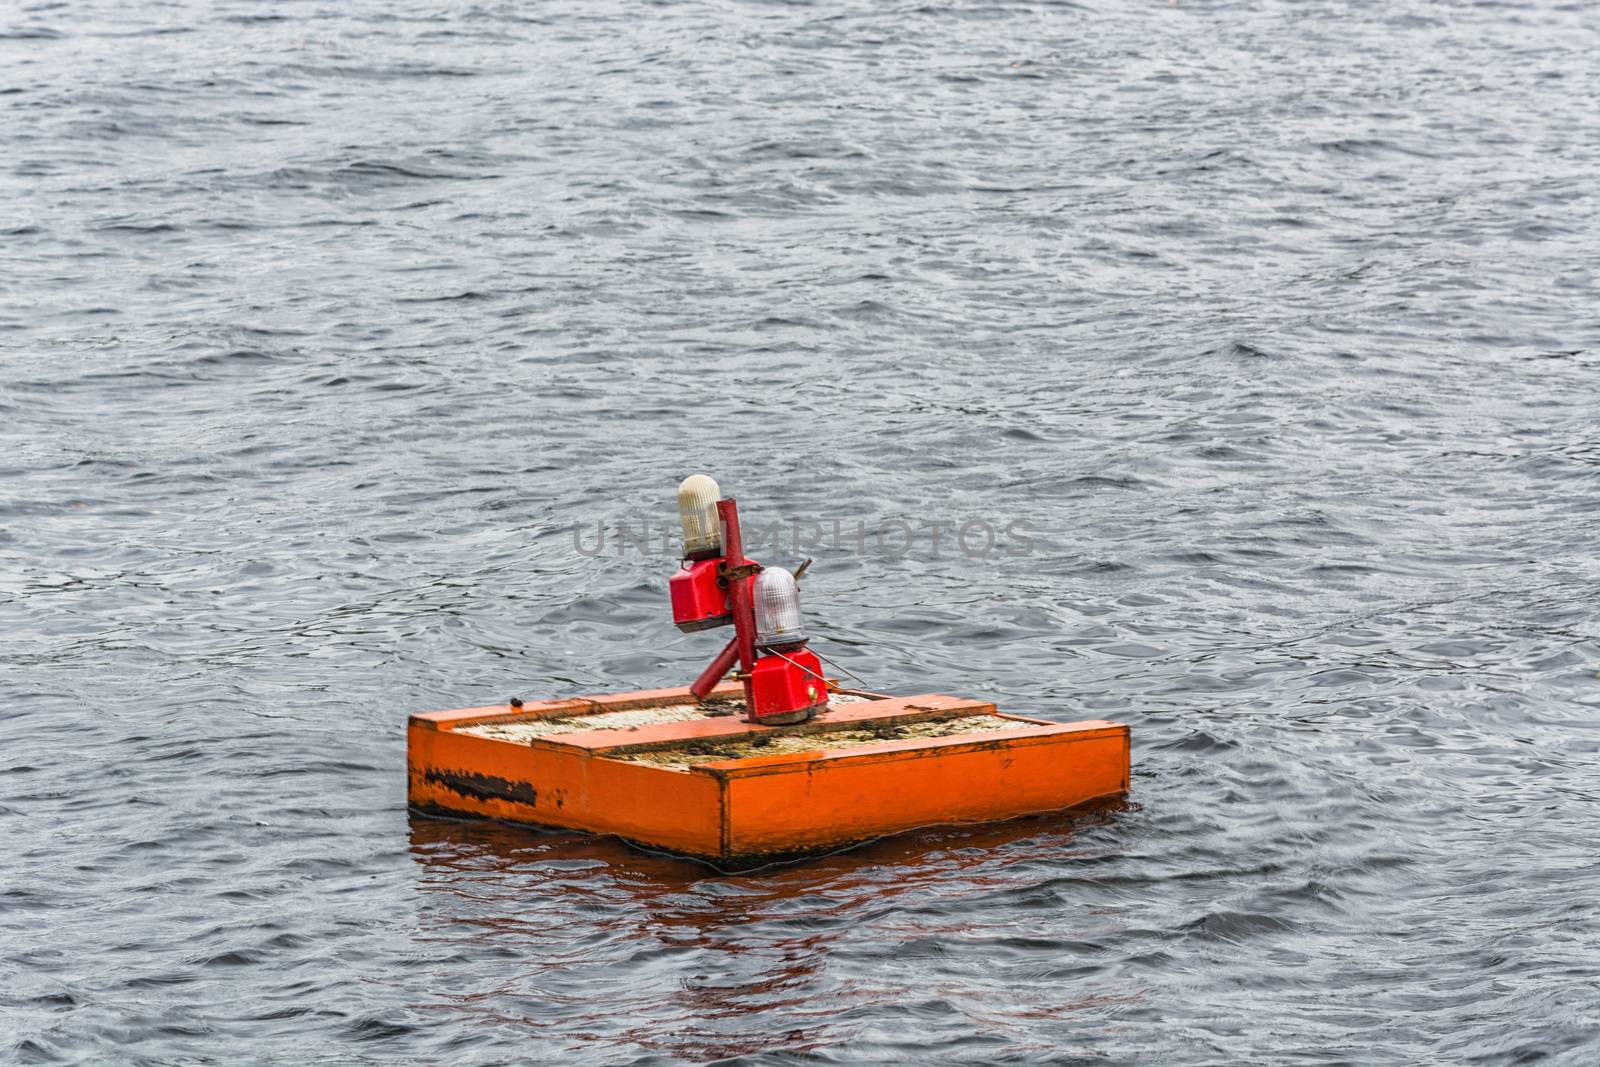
[406,723,723,856]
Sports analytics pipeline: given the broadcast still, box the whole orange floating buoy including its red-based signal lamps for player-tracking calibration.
[406,475,1130,865]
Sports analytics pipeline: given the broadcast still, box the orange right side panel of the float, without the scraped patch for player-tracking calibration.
[723,721,1130,856]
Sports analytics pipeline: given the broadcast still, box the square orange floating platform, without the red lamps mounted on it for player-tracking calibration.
[406,683,1128,867]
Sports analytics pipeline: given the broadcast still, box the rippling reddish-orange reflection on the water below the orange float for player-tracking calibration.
[400,800,1128,1061]
